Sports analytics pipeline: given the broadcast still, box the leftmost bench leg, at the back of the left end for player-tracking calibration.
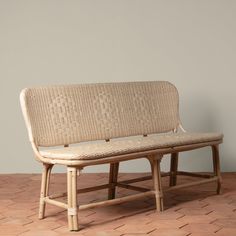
[39,164,53,219]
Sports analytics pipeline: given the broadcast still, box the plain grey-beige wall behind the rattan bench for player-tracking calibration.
[0,0,236,173]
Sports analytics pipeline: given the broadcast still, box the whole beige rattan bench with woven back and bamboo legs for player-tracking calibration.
[20,81,223,230]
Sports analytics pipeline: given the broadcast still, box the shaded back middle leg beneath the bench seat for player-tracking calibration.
[108,162,119,199]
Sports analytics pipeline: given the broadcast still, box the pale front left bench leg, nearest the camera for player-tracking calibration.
[67,167,79,231]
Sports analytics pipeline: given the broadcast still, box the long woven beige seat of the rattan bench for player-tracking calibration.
[40,133,223,160]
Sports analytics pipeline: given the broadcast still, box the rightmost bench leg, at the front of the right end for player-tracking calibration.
[212,145,222,194]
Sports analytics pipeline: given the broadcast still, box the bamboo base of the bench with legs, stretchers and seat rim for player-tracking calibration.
[32,129,222,231]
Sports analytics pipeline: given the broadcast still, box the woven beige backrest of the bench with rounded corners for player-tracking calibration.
[21,81,179,146]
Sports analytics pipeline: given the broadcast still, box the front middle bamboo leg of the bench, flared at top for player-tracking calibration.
[149,156,164,212]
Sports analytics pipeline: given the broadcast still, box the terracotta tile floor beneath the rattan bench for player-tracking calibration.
[0,173,236,236]
